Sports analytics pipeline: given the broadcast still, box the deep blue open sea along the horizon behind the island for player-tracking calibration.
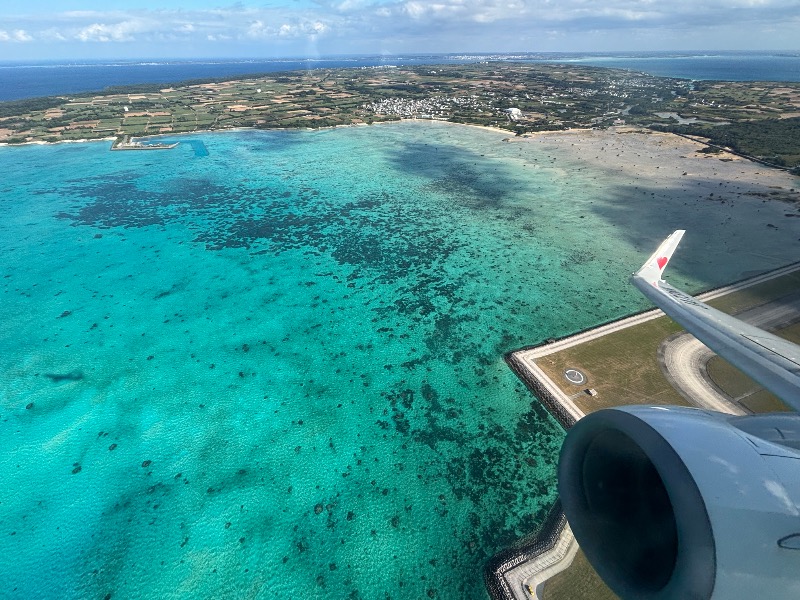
[0,53,800,101]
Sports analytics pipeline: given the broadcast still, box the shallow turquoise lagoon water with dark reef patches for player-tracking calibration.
[0,123,798,599]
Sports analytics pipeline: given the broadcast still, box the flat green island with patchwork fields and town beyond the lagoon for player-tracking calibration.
[0,62,800,169]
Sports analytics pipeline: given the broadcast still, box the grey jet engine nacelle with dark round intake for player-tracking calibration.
[558,406,800,600]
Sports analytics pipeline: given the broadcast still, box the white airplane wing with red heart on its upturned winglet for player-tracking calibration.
[632,229,800,411]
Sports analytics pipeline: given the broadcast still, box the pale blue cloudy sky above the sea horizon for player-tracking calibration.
[0,0,800,60]
